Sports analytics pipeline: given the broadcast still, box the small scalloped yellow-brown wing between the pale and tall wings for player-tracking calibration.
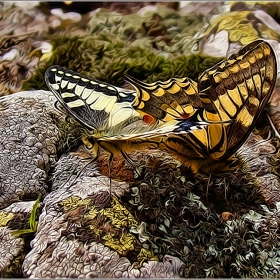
[125,76,202,122]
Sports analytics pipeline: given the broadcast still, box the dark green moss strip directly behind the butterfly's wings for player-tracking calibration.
[24,31,223,90]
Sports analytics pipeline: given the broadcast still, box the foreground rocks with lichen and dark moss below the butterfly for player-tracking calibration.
[0,91,280,278]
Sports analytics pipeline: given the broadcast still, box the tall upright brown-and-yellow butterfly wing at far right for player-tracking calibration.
[198,40,277,159]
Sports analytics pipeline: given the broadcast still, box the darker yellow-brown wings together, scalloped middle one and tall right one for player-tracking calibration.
[127,40,277,163]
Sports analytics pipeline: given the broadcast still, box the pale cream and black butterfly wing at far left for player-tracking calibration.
[45,65,139,131]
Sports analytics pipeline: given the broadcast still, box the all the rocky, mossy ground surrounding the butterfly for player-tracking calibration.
[0,2,280,278]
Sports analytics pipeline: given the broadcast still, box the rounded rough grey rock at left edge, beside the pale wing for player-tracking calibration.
[0,91,59,209]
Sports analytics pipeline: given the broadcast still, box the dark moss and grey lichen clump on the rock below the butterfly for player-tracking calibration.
[117,153,280,278]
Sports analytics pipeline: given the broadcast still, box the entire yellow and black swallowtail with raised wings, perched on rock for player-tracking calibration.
[45,40,277,174]
